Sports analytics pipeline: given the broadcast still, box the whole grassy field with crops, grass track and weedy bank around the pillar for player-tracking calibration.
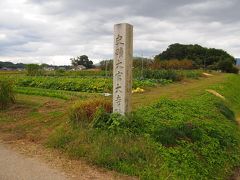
[0,73,240,179]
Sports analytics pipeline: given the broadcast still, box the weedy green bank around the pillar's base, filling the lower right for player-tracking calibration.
[47,76,240,179]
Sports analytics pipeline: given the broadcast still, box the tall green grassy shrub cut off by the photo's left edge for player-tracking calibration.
[0,80,15,109]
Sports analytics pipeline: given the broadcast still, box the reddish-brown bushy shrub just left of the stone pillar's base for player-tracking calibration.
[70,98,112,124]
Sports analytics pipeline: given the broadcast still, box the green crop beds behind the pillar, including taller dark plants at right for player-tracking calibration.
[9,70,202,93]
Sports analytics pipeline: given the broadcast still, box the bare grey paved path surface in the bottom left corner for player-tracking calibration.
[0,143,68,180]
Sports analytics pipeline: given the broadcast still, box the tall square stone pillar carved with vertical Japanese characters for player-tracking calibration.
[113,23,133,115]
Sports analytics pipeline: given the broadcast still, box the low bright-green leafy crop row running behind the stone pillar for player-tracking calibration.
[15,76,157,93]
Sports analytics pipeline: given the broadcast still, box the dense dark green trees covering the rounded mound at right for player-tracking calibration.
[155,43,236,67]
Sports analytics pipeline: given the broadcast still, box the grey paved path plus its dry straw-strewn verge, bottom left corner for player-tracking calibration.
[0,134,136,180]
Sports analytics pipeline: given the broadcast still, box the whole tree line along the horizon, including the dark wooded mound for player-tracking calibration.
[0,43,239,73]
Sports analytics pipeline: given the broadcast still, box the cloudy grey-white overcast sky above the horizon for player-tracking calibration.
[0,0,240,65]
